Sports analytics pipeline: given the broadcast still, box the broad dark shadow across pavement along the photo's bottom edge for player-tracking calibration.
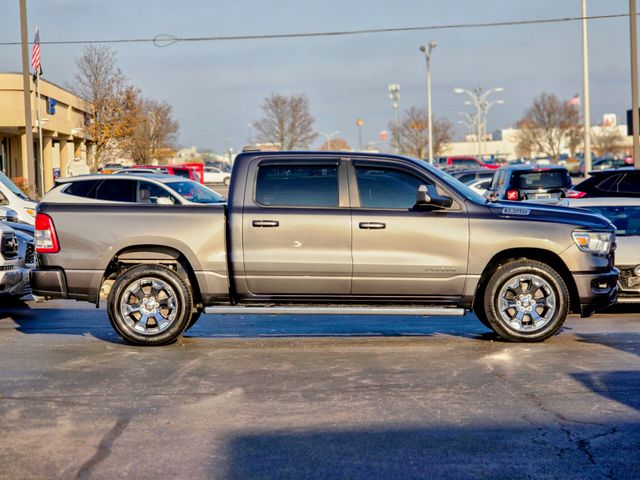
[215,420,640,480]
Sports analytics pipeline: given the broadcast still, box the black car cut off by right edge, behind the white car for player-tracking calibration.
[567,168,640,198]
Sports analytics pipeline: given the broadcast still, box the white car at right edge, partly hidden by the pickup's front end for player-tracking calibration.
[561,197,640,303]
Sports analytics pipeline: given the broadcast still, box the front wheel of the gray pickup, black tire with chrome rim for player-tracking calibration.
[478,258,569,342]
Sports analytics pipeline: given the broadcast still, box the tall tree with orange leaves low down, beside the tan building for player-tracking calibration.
[69,45,127,170]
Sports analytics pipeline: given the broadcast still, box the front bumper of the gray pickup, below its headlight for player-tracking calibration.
[574,268,620,317]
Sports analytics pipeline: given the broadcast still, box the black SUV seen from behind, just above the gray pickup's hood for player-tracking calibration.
[486,165,571,203]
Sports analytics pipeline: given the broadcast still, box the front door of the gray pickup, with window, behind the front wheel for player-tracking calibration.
[349,161,469,299]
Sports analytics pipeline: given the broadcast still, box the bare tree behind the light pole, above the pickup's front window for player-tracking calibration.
[389,107,453,159]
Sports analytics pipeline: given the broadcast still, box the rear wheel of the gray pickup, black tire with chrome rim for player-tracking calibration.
[107,265,193,346]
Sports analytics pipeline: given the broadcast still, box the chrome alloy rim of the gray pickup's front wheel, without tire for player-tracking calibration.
[498,274,556,332]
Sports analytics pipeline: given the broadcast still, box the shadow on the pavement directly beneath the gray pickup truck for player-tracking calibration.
[0,304,501,343]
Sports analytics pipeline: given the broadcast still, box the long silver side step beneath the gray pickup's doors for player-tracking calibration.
[204,306,466,317]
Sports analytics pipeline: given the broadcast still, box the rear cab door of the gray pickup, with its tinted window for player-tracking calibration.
[242,157,352,296]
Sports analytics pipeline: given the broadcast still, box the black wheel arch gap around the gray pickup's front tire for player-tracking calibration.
[473,248,580,313]
